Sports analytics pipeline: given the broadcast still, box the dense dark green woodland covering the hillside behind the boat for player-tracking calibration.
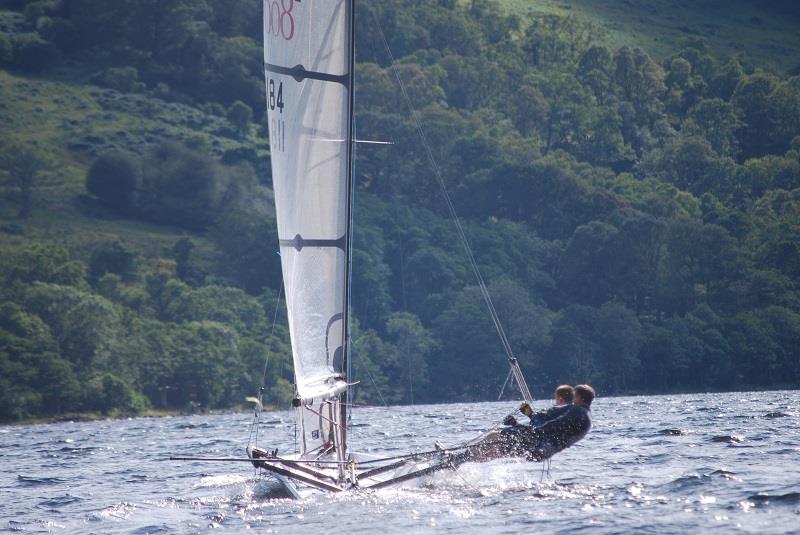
[0,0,800,420]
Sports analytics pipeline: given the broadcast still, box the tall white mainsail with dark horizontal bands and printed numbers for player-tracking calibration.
[264,0,352,455]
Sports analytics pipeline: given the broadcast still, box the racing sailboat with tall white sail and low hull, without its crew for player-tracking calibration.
[247,0,530,497]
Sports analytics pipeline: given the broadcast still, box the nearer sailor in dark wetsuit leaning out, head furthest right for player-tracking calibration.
[468,385,595,461]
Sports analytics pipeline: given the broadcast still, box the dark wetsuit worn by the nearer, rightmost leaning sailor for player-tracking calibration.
[500,405,592,461]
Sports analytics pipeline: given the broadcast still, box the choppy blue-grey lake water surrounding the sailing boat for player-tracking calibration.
[0,391,800,535]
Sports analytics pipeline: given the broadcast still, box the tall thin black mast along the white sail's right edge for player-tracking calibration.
[339,0,356,460]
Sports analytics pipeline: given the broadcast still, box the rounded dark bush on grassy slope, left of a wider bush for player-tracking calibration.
[86,151,142,211]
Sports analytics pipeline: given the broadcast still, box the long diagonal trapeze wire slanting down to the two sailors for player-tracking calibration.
[370,10,533,403]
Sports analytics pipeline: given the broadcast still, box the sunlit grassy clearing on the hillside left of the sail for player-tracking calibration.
[0,71,266,264]
